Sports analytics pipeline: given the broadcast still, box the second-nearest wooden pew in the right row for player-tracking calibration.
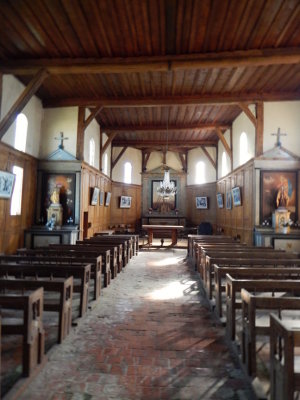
[241,289,300,377]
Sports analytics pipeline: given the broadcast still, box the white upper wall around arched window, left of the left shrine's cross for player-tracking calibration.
[1,75,43,157]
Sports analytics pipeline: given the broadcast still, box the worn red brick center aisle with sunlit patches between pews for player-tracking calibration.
[20,249,253,400]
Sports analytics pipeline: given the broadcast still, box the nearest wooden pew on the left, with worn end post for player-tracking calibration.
[0,287,45,376]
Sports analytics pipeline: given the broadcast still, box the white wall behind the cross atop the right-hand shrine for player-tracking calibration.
[264,101,300,156]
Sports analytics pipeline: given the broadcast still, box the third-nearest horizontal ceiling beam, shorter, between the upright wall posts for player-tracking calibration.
[102,123,230,133]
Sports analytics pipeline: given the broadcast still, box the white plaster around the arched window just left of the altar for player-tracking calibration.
[112,147,142,185]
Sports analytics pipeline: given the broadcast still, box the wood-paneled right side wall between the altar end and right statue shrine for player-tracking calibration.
[216,160,255,245]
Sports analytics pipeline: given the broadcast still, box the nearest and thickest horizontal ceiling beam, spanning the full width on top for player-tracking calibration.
[0,47,300,75]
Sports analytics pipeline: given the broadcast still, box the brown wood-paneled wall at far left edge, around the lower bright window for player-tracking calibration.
[0,143,37,254]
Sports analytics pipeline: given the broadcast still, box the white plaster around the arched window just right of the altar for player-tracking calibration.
[187,147,217,185]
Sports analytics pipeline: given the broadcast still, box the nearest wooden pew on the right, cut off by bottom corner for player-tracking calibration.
[270,314,300,400]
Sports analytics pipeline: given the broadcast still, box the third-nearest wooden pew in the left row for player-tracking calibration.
[0,263,91,317]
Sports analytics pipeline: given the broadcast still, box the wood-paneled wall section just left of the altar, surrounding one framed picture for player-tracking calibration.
[110,182,142,229]
